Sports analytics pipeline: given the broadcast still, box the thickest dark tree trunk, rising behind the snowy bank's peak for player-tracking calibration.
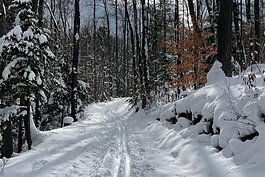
[217,0,233,76]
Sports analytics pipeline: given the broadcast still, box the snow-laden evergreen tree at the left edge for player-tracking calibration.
[0,0,55,152]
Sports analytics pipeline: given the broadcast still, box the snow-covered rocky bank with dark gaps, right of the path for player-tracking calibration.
[149,62,265,169]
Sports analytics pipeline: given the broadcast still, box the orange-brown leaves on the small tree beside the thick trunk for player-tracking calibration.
[167,30,216,88]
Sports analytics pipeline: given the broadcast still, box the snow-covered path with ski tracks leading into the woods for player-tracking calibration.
[0,99,243,177]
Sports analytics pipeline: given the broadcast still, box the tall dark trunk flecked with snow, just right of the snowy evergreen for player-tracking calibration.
[71,0,80,121]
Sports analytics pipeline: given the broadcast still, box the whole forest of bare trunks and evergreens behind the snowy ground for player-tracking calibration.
[0,0,265,166]
